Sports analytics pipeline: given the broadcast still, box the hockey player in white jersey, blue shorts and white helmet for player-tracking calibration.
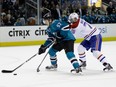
[68,13,113,71]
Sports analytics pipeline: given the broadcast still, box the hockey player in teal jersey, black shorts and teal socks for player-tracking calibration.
[38,15,82,73]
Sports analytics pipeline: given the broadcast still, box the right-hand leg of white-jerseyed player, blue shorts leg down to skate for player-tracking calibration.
[90,34,113,70]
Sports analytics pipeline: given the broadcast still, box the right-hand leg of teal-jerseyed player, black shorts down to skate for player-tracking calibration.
[64,40,82,73]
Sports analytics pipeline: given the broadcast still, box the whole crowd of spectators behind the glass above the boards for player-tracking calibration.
[0,0,116,26]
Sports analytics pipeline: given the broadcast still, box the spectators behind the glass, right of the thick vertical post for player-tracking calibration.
[42,0,116,23]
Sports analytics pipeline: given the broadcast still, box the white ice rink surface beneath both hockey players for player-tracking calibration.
[0,41,116,87]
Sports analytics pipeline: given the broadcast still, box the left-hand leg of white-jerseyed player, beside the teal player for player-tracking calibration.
[78,40,90,68]
